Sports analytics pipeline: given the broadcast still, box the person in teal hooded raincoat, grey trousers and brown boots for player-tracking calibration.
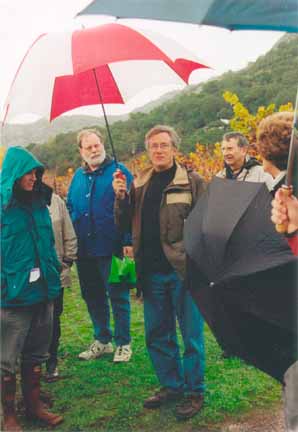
[1,147,62,431]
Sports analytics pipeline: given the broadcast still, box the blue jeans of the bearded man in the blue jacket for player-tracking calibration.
[77,257,130,346]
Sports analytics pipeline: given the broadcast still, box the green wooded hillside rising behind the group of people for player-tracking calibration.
[24,35,298,171]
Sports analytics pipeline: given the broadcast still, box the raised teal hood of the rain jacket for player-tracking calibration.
[1,146,44,207]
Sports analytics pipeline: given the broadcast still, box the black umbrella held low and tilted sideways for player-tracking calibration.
[184,178,298,381]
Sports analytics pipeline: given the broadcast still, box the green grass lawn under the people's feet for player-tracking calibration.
[25,271,281,432]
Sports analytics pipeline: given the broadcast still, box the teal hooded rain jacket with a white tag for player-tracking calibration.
[1,147,61,308]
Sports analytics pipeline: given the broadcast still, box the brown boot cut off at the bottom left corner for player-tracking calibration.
[1,374,22,432]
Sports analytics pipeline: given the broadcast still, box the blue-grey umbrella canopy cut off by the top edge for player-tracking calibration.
[79,0,298,32]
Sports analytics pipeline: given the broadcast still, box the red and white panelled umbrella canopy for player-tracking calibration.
[4,23,207,122]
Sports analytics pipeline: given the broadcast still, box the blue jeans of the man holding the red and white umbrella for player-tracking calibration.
[143,271,205,393]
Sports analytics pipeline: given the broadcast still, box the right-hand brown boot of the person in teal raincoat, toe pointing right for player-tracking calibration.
[21,364,63,426]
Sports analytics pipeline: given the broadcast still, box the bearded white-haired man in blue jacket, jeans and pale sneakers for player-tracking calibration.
[67,129,132,363]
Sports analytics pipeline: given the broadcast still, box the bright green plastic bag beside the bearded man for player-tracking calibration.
[109,255,137,285]
